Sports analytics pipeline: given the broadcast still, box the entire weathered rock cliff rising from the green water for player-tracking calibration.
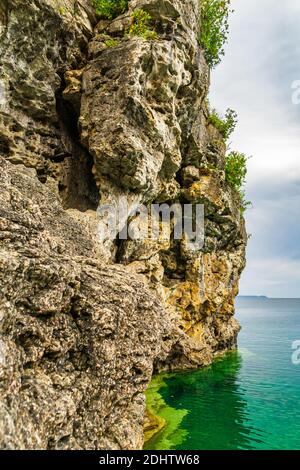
[0,0,246,449]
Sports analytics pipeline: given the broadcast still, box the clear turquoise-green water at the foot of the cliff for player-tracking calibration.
[146,299,300,450]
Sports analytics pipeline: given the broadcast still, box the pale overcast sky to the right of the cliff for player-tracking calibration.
[210,0,300,297]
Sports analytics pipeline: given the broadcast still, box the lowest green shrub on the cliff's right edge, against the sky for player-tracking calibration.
[225,152,251,213]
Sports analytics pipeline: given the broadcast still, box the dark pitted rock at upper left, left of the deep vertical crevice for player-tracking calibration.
[0,0,97,210]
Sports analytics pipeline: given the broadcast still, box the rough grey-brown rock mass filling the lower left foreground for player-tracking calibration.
[0,159,166,449]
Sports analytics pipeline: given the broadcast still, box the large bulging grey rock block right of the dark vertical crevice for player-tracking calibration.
[79,1,208,195]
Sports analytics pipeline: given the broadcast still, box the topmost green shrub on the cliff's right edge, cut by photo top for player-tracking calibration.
[199,0,232,67]
